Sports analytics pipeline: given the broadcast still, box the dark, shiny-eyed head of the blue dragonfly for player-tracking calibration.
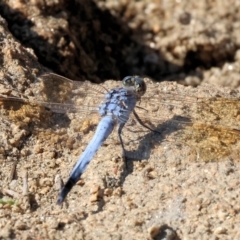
[122,76,147,97]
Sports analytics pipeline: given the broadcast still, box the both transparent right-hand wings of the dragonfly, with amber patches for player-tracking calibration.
[130,79,240,161]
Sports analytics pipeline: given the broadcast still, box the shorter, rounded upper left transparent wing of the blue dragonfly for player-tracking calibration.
[33,73,107,113]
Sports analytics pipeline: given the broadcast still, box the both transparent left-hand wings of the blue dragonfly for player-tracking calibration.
[0,73,112,132]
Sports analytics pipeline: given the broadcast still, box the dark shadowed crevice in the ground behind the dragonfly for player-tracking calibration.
[0,0,236,82]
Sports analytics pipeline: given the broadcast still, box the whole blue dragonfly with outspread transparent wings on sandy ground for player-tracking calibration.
[0,73,240,204]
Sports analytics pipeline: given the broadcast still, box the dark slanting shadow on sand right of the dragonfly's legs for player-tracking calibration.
[126,115,191,172]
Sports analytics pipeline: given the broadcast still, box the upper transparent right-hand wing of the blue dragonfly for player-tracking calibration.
[140,78,240,128]
